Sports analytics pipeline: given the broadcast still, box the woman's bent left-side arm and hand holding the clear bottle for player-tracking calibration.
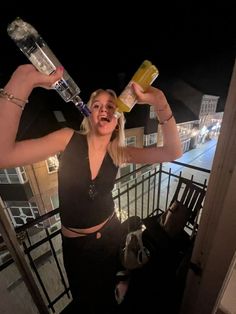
[0,64,72,168]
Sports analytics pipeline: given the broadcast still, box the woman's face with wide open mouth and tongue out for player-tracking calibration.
[89,91,117,135]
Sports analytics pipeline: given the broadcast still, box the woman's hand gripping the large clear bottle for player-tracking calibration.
[11,64,63,89]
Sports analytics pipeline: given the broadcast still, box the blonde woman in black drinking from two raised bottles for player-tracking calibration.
[0,64,182,313]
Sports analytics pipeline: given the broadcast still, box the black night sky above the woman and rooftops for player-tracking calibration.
[0,0,236,98]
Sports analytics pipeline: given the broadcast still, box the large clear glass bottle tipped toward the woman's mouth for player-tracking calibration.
[7,17,90,116]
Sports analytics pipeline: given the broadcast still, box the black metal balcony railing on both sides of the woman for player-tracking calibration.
[0,161,210,313]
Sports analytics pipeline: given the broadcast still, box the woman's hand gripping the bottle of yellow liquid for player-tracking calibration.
[132,82,167,107]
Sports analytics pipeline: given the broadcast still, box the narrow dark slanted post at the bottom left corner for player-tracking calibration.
[0,203,49,314]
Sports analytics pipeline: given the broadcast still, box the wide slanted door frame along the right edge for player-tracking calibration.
[181,62,236,314]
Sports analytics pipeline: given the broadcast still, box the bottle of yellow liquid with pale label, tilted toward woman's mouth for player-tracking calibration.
[115,60,159,117]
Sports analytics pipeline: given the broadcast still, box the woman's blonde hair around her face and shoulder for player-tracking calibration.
[80,89,127,166]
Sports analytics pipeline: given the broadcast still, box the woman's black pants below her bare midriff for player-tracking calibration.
[62,216,122,314]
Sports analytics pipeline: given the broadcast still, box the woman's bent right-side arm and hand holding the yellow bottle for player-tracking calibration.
[126,83,182,163]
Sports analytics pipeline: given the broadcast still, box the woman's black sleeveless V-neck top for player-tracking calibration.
[58,132,118,229]
